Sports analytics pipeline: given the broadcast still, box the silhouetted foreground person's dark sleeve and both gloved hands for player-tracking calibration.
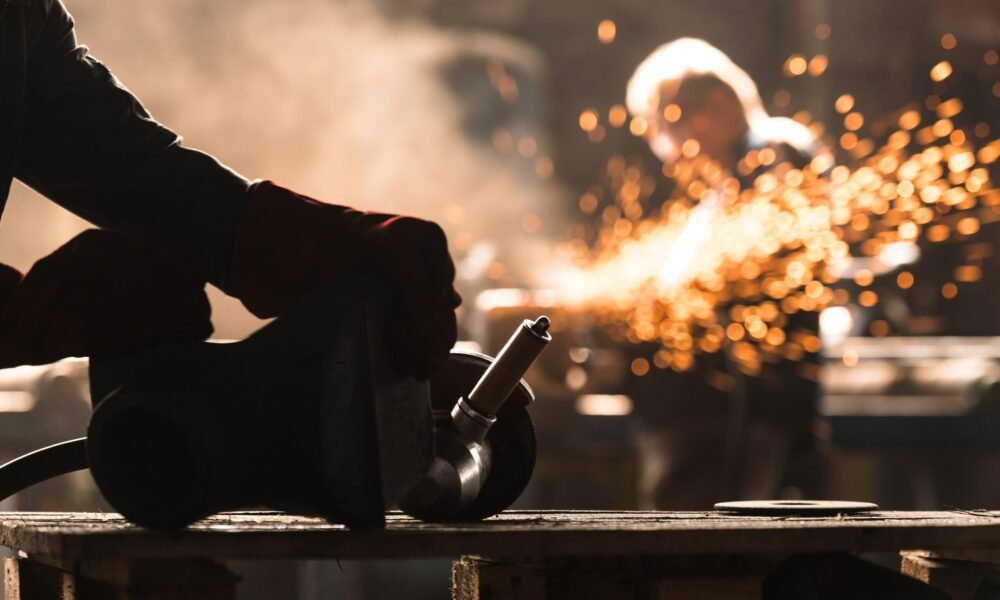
[0,0,459,377]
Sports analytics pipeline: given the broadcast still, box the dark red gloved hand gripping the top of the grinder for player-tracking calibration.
[224,181,461,379]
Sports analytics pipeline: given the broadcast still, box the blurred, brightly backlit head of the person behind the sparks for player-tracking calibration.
[626,38,767,163]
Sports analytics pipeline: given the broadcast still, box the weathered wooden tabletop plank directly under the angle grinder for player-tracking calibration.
[0,511,1000,560]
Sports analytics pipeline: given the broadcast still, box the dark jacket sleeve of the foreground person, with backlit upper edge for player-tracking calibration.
[15,0,248,285]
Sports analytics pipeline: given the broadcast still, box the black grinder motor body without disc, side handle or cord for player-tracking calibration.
[87,286,433,529]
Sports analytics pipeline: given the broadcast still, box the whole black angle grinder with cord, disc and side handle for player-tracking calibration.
[0,292,551,529]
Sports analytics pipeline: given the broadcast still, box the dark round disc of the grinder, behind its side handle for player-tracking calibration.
[431,350,537,521]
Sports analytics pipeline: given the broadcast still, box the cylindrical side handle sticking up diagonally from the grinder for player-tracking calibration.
[466,316,552,416]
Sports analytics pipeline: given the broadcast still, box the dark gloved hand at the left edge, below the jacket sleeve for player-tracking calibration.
[0,230,212,367]
